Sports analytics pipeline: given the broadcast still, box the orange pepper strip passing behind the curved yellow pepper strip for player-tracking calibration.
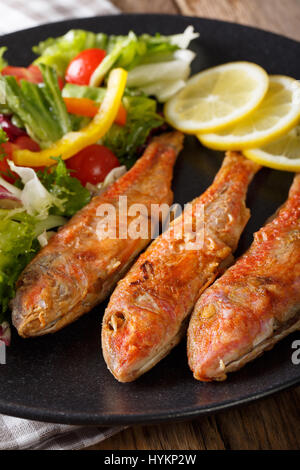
[64,98,127,126]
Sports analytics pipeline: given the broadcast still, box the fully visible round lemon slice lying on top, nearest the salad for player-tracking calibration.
[164,62,269,133]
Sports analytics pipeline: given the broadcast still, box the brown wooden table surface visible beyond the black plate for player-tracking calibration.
[91,0,300,450]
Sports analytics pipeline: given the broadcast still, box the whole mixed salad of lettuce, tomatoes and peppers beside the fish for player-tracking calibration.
[0,26,198,344]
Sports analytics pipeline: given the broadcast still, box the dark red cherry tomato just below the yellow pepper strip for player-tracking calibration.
[66,144,120,185]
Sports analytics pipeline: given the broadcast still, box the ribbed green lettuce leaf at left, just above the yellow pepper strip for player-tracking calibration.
[1,65,71,149]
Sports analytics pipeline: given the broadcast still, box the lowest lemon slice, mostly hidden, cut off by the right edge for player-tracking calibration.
[243,126,300,172]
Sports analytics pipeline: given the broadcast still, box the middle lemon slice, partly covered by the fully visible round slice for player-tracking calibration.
[198,75,300,150]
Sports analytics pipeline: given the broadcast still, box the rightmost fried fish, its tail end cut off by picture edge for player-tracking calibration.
[188,174,300,381]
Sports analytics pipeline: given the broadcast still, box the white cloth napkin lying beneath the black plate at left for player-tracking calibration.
[0,0,124,450]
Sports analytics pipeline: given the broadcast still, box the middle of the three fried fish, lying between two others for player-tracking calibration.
[102,152,259,382]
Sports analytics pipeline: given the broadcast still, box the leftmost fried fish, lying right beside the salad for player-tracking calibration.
[12,132,183,337]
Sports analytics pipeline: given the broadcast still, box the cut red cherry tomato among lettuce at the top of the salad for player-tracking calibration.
[65,49,106,85]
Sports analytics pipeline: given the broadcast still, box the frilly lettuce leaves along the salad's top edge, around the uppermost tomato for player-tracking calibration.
[33,26,199,101]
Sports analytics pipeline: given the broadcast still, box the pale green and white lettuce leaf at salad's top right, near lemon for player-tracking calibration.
[90,27,198,101]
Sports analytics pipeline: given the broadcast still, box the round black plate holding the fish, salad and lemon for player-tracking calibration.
[0,15,300,424]
